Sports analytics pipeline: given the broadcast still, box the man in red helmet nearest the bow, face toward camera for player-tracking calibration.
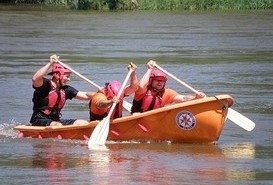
[131,60,206,113]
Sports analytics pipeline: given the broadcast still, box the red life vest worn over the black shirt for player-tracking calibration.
[43,84,66,115]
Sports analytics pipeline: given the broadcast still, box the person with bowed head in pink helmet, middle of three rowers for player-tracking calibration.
[89,63,138,121]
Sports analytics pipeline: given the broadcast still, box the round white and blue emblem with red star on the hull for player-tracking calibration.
[176,111,196,130]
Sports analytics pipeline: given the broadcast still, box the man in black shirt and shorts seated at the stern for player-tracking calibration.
[30,55,95,126]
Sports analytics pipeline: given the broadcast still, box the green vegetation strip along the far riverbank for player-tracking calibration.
[0,0,273,11]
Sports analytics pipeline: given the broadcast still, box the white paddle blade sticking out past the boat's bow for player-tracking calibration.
[227,108,255,131]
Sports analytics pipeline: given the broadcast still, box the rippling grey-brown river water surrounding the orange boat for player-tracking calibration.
[0,5,273,185]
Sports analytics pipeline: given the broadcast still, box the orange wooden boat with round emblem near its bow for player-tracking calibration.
[14,95,234,143]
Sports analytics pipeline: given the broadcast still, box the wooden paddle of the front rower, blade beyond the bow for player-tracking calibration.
[155,64,255,131]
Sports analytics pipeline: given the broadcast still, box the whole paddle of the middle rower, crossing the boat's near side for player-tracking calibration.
[88,69,133,148]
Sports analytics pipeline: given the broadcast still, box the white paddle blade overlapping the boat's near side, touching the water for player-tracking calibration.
[88,116,110,148]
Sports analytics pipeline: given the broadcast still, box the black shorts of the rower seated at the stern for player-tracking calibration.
[30,113,76,126]
